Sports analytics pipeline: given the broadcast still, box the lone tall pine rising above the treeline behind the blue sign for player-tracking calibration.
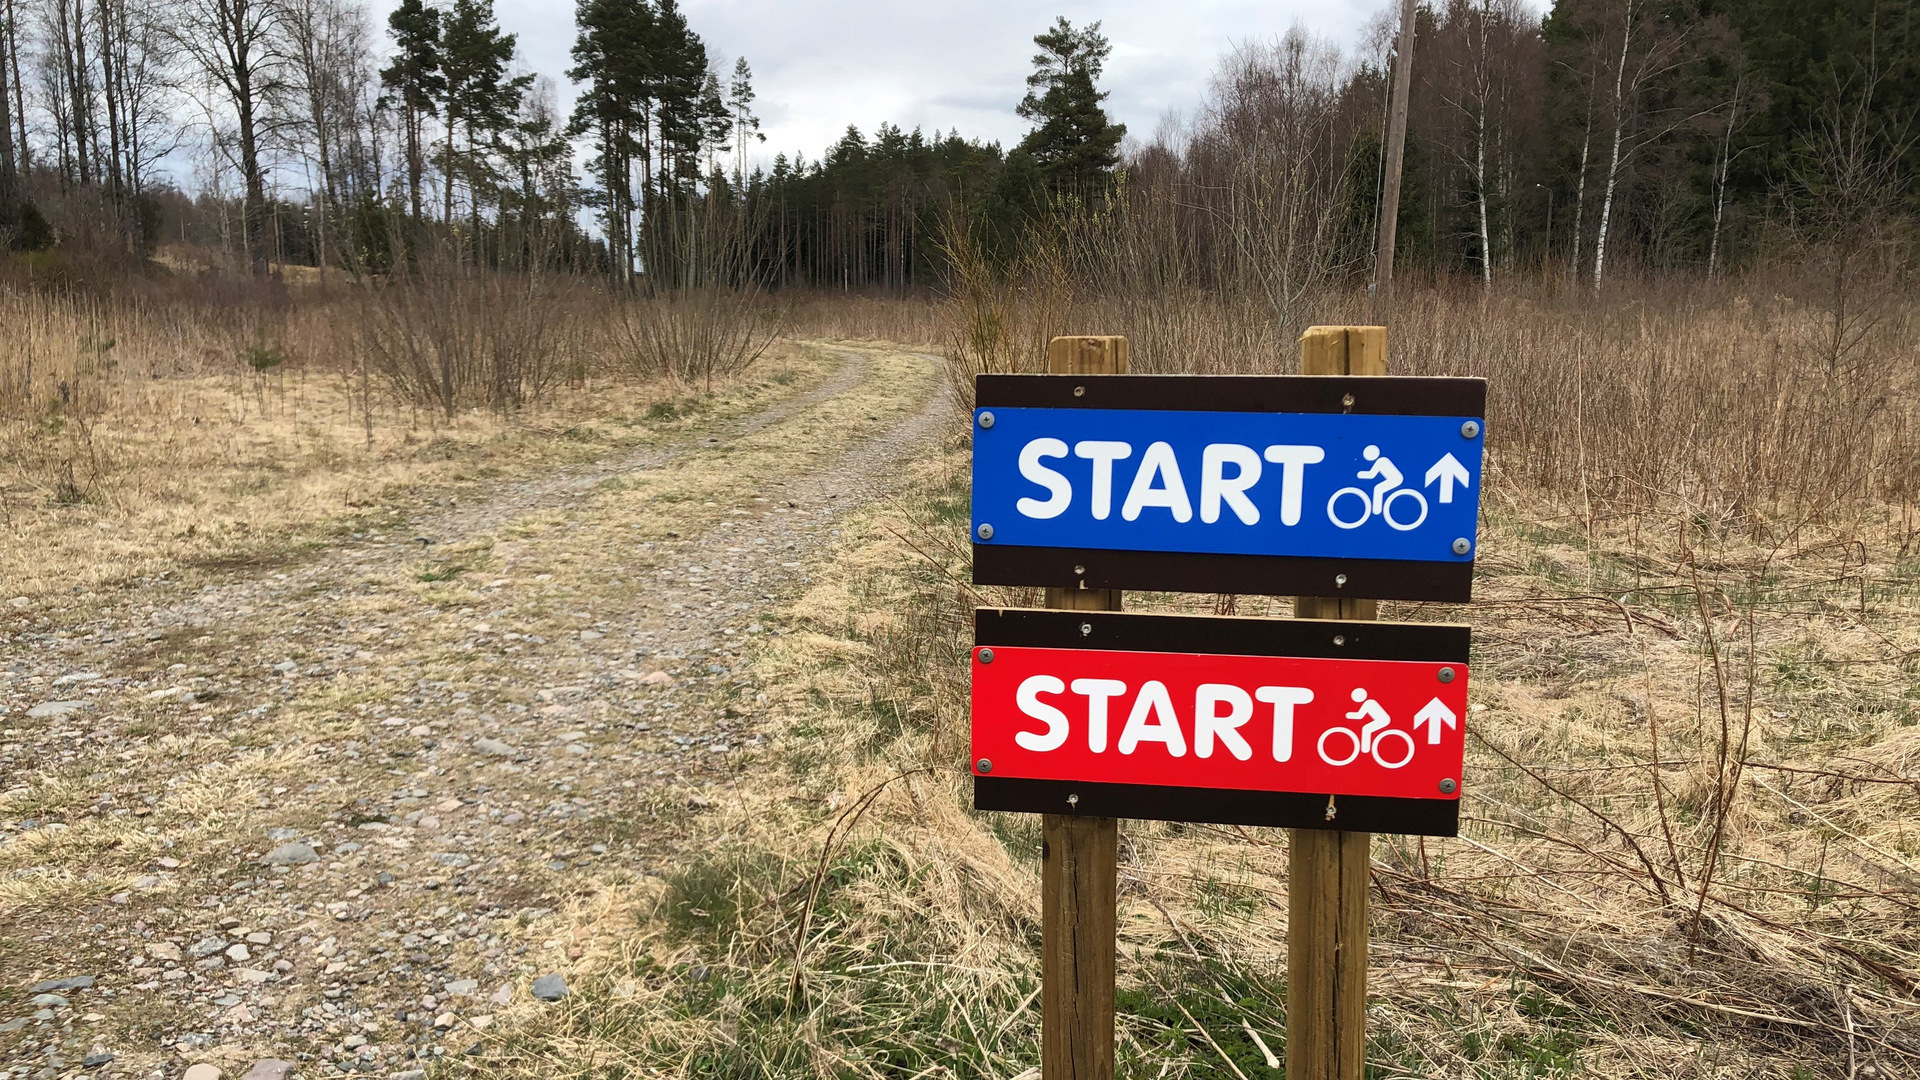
[1018,17,1127,200]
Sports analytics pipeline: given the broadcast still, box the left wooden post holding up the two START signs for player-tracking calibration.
[1041,336,1127,1080]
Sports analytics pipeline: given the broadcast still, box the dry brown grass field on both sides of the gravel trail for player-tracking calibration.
[0,279,1920,1080]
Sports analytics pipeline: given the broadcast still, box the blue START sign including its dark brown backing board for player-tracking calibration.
[972,377,1486,600]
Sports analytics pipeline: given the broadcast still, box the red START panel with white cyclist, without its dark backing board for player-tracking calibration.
[973,646,1467,799]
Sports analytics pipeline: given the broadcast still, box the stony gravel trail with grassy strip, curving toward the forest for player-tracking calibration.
[0,350,947,1078]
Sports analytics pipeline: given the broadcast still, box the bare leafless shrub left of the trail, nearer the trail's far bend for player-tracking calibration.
[616,194,785,388]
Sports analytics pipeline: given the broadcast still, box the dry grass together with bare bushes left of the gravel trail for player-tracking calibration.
[0,275,898,598]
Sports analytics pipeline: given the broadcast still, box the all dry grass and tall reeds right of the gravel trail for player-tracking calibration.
[476,272,1920,1080]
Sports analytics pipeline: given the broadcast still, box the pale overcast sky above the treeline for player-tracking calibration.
[428,0,1390,161]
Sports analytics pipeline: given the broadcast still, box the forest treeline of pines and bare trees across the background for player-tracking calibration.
[0,0,1920,290]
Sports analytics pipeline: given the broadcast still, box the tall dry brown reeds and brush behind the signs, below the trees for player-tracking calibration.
[945,212,1920,527]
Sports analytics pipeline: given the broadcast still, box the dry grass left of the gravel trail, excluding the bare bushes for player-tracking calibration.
[0,284,860,600]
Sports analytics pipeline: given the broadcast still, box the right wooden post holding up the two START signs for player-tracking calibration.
[1286,327,1386,1080]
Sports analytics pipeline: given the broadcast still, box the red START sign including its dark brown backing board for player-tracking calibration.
[972,611,1467,832]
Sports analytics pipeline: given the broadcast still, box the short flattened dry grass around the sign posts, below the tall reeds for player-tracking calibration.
[476,424,1920,1078]
